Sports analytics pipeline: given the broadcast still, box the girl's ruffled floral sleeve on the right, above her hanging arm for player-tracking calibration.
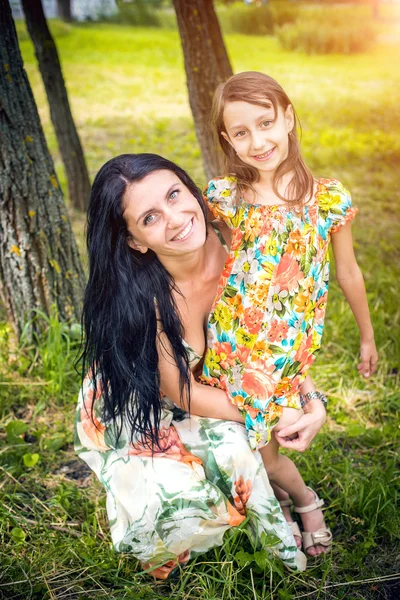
[317,179,358,233]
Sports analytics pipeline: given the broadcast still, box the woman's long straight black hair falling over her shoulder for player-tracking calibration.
[82,154,206,448]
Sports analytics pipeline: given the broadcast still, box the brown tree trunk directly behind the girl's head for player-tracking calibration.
[174,0,232,179]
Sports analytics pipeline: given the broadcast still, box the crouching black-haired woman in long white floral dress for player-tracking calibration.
[76,154,325,578]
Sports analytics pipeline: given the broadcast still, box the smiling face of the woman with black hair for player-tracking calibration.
[123,170,206,257]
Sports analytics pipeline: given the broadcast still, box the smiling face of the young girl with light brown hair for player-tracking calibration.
[222,102,294,173]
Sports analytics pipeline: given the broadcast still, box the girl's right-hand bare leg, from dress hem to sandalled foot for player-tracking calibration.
[260,436,329,556]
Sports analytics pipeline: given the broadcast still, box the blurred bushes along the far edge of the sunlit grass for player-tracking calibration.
[111,0,398,54]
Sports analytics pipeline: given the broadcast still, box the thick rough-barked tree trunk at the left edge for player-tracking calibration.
[0,0,85,335]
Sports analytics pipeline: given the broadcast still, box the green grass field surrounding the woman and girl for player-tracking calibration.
[0,9,400,600]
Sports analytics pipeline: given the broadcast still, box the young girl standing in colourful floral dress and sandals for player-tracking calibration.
[202,72,377,554]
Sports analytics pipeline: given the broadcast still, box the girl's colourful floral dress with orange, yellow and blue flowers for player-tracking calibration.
[202,177,357,449]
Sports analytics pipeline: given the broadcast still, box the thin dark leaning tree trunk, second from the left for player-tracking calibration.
[22,0,90,210]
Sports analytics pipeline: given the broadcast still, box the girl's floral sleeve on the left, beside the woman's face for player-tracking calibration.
[204,177,238,229]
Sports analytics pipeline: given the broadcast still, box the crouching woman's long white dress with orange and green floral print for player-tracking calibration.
[75,238,306,578]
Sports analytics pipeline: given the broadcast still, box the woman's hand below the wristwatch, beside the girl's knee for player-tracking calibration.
[275,398,326,452]
